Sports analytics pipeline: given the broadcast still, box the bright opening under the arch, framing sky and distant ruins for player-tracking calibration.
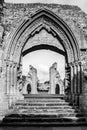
[22,45,65,94]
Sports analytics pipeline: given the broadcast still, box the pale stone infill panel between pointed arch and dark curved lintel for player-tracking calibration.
[22,29,64,52]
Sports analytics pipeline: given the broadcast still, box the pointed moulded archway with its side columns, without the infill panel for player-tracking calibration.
[3,9,82,107]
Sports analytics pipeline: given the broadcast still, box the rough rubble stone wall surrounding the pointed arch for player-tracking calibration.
[0,3,87,114]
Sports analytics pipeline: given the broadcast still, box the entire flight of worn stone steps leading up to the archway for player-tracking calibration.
[2,95,86,123]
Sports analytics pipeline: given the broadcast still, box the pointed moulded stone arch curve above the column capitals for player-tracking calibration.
[4,9,80,63]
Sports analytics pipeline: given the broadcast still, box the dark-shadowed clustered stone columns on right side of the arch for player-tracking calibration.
[70,63,82,104]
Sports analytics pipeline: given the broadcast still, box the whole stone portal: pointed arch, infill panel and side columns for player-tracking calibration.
[3,9,82,110]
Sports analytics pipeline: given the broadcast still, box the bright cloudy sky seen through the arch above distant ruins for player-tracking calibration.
[23,49,65,82]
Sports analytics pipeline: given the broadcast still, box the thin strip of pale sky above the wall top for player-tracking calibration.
[5,0,87,13]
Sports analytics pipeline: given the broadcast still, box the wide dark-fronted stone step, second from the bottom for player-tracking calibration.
[6,112,85,119]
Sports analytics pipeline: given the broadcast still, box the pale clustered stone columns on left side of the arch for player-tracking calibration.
[6,61,17,106]
